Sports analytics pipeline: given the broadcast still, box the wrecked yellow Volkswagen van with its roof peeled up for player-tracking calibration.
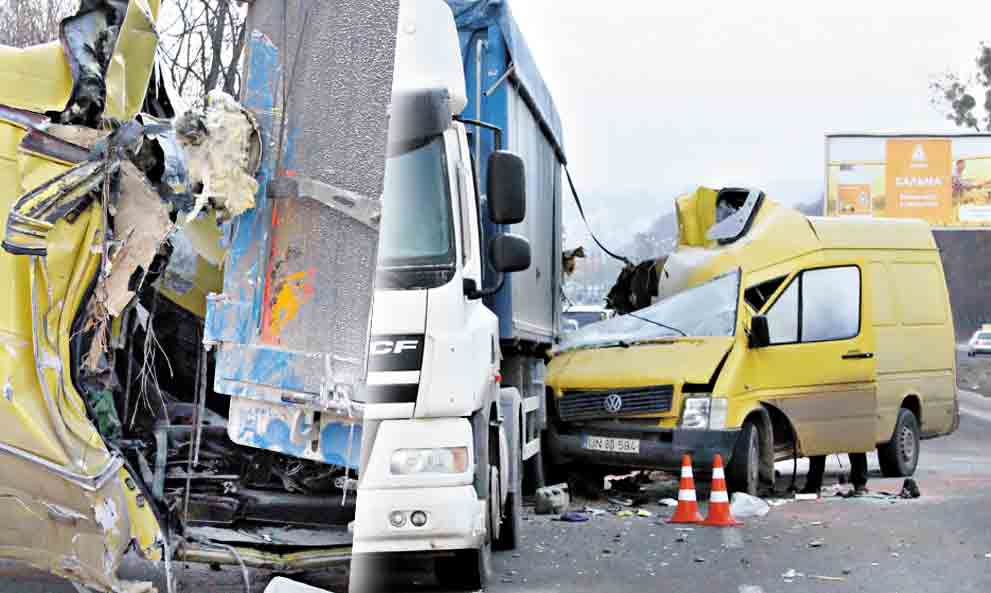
[545,188,959,493]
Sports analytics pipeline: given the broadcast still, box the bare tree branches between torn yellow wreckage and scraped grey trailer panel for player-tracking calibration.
[161,0,245,101]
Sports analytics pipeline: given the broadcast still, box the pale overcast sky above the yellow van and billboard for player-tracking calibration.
[510,0,991,243]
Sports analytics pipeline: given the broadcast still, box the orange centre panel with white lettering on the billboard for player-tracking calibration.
[884,138,953,224]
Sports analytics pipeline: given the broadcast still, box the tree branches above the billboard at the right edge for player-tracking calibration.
[929,43,991,132]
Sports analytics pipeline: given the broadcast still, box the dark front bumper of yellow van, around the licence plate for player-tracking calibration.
[551,427,740,471]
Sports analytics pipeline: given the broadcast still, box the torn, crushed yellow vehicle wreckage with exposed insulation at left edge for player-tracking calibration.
[0,0,362,591]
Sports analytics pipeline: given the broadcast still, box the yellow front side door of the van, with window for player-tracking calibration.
[746,260,877,455]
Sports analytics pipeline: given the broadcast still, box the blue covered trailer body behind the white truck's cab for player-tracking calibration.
[447,0,567,345]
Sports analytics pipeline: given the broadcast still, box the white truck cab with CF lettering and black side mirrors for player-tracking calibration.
[352,0,530,590]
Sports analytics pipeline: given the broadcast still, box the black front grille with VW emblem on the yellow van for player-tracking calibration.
[557,385,674,422]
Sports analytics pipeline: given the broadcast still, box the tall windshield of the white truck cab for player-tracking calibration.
[379,136,454,267]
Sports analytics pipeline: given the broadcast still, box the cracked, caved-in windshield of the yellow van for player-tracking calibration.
[555,271,740,352]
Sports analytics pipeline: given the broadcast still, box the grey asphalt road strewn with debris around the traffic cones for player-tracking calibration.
[0,393,991,593]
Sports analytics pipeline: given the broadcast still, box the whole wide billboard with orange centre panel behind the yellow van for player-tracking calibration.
[825,134,991,228]
